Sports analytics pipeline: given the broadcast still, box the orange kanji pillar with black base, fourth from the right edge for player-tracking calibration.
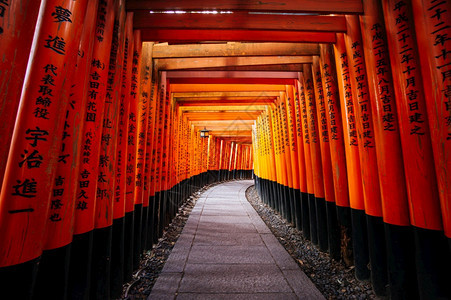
[345,15,387,288]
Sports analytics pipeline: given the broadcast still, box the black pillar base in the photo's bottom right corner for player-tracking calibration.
[414,227,451,299]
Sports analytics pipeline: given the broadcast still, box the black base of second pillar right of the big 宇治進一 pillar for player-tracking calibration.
[68,231,94,300]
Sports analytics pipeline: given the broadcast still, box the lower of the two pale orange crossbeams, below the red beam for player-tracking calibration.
[155,56,313,70]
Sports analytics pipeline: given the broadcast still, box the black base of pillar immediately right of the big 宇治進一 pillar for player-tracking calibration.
[33,244,71,299]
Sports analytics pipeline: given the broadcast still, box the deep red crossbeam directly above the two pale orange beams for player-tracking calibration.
[141,29,337,43]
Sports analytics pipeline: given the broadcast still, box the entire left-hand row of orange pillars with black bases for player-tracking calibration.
[0,0,252,299]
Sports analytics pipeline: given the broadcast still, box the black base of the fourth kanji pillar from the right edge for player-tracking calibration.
[366,215,388,296]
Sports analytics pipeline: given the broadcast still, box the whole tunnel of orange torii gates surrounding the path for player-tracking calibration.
[0,0,451,299]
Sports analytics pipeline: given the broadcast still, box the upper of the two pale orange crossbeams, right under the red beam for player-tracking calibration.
[152,42,319,58]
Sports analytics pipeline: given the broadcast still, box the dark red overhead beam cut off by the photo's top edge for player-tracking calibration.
[127,0,363,14]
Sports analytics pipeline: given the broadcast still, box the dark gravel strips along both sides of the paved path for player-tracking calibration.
[122,184,381,300]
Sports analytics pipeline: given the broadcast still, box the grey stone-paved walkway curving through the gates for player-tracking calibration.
[148,180,324,300]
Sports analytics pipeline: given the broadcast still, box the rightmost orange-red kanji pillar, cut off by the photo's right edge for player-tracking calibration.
[412,0,451,256]
